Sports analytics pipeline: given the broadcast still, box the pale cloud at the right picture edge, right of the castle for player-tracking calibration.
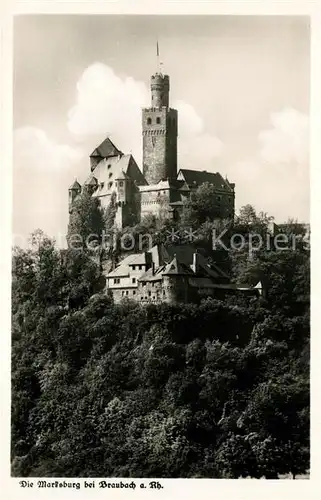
[229,108,310,222]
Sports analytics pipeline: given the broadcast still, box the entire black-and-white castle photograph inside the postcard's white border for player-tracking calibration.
[10,9,311,482]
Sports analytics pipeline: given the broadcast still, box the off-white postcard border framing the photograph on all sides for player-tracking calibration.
[0,0,321,500]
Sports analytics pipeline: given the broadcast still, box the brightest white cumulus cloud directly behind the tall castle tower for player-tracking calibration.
[68,63,222,169]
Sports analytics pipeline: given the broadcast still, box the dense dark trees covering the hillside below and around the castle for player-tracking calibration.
[12,202,309,478]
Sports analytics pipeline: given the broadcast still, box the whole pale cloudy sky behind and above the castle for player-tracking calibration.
[13,15,310,239]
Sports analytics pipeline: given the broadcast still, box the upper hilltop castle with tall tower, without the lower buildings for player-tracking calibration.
[69,67,235,228]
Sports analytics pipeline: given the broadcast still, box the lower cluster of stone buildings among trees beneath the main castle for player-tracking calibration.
[106,245,263,304]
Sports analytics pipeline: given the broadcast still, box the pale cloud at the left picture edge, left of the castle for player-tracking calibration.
[13,127,82,244]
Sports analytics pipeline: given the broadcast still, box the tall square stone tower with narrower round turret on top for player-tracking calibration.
[142,72,177,184]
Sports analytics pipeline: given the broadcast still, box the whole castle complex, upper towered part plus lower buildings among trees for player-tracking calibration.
[65,64,262,304]
